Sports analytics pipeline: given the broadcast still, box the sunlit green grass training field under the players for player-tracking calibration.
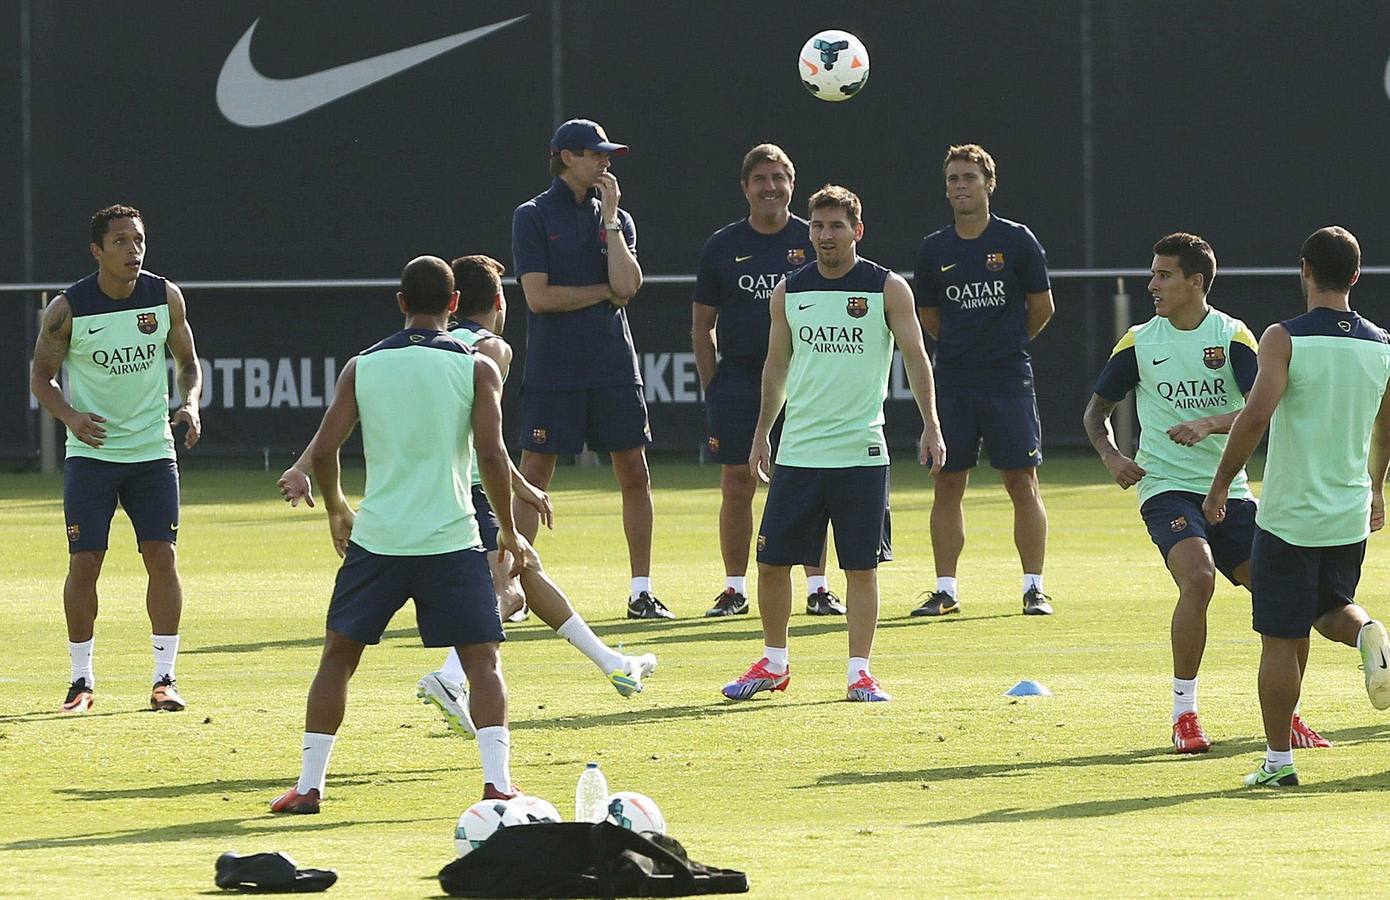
[0,456,1390,897]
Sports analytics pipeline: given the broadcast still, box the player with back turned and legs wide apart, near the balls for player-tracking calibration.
[271,256,525,814]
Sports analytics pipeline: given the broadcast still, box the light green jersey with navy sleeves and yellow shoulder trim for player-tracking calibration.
[1097,309,1257,505]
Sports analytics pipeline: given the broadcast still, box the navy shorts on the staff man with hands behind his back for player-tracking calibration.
[937,394,1043,472]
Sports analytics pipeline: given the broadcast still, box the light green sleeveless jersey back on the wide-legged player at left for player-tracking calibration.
[352,328,482,556]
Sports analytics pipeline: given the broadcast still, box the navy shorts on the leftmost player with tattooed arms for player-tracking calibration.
[63,456,178,554]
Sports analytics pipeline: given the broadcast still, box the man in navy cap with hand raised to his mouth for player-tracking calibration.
[512,118,674,619]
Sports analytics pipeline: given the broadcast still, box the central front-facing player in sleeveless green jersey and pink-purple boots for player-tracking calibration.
[723,185,947,701]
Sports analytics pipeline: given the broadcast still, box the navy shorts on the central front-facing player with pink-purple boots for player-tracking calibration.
[758,466,892,572]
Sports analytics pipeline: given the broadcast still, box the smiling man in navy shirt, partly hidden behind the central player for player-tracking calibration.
[691,143,845,616]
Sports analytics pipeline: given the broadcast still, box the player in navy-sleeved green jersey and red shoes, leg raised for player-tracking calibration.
[1086,232,1332,753]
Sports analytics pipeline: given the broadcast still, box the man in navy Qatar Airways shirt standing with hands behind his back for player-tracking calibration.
[912,143,1054,616]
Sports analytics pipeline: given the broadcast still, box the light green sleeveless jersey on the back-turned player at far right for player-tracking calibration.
[1255,306,1390,547]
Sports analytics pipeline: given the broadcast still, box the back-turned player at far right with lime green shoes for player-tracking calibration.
[1202,225,1390,787]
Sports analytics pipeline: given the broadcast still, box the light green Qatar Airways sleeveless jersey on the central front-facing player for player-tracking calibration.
[777,259,892,469]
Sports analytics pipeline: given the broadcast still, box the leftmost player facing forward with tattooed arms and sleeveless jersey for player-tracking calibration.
[29,206,203,712]
